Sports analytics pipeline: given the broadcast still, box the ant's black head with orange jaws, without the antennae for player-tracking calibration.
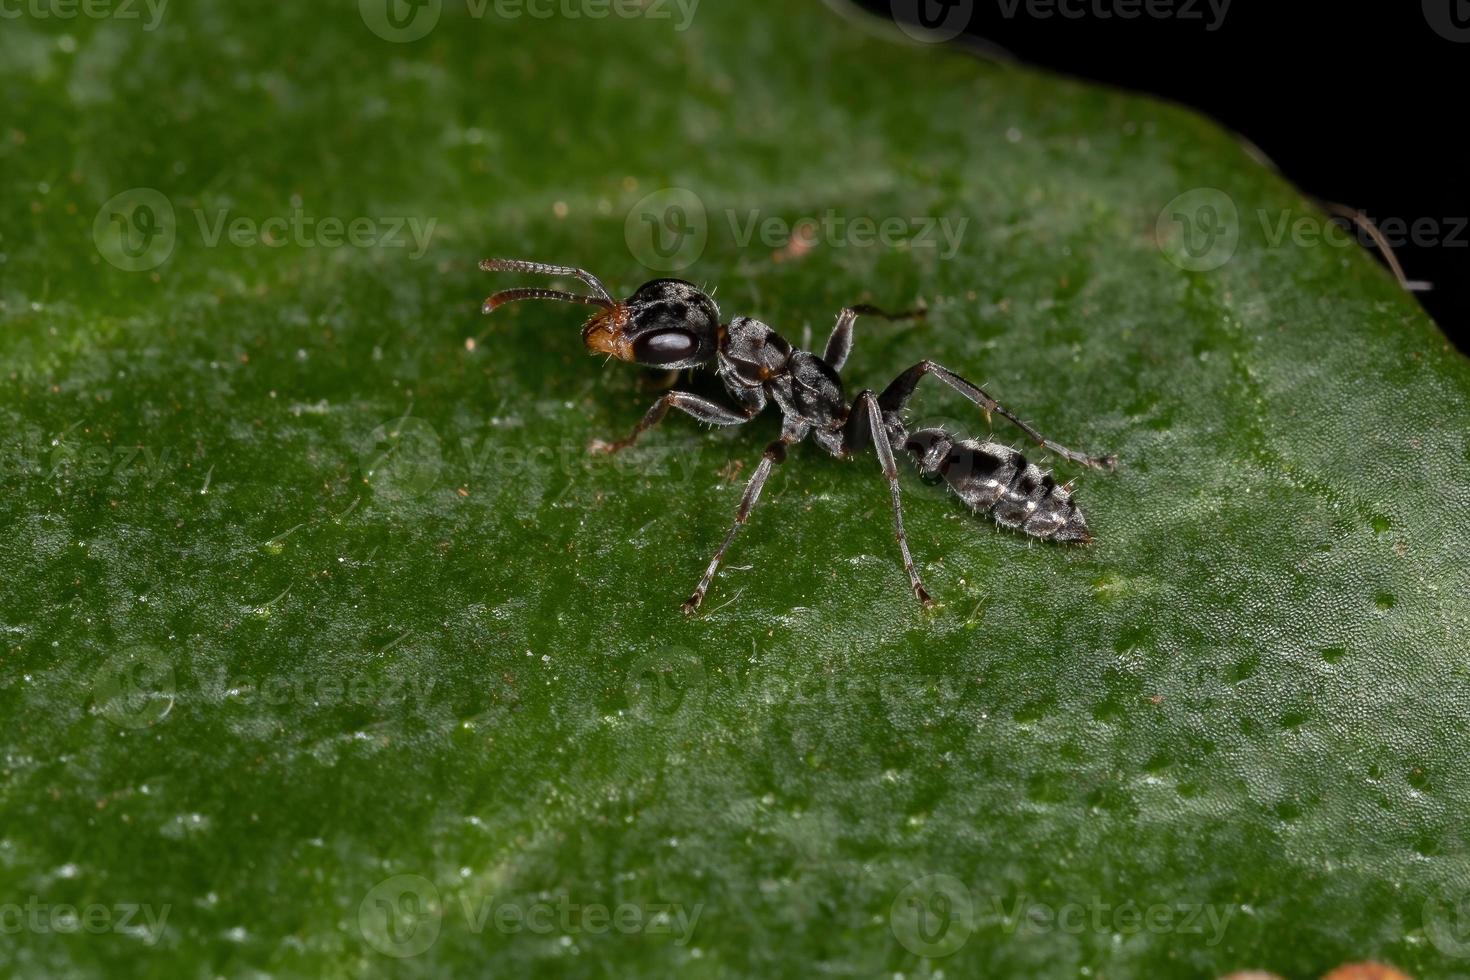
[582,279,720,370]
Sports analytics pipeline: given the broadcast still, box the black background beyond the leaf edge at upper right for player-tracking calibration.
[858,0,1470,353]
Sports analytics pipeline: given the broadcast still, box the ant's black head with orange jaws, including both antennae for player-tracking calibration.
[479,259,720,369]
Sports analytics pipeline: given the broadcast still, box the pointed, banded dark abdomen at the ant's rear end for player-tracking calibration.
[904,429,1092,542]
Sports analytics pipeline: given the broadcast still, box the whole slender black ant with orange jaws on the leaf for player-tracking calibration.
[479,259,1117,613]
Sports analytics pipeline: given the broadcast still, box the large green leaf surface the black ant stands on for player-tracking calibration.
[0,0,1470,977]
